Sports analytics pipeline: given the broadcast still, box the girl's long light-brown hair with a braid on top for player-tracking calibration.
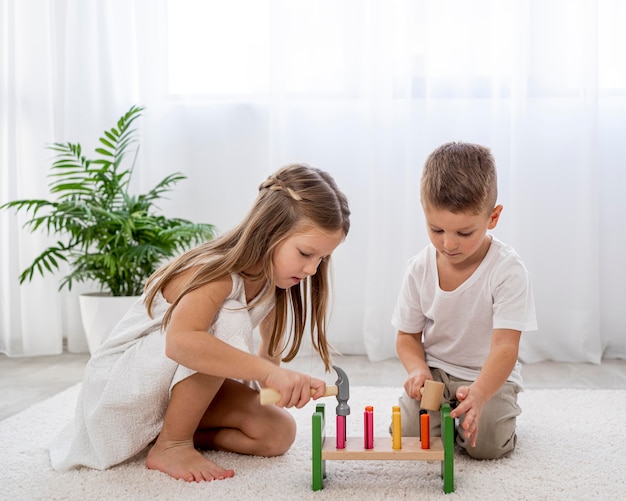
[145,164,350,371]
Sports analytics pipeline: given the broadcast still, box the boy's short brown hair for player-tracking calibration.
[421,142,498,214]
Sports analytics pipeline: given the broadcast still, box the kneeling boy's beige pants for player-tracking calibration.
[399,369,522,459]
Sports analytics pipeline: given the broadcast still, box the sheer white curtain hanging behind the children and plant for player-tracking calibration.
[0,0,626,363]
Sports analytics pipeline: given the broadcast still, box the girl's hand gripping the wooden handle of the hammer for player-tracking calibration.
[264,367,326,409]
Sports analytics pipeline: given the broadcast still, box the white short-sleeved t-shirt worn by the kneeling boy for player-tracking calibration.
[391,236,537,387]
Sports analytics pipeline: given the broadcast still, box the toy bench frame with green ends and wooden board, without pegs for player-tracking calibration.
[311,404,454,494]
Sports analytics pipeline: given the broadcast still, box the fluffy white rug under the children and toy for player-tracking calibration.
[0,385,626,501]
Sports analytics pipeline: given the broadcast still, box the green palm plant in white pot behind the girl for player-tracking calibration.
[0,106,215,352]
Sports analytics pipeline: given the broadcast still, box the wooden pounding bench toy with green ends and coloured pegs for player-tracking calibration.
[311,376,454,494]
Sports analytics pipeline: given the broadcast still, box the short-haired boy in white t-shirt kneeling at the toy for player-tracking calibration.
[392,143,537,459]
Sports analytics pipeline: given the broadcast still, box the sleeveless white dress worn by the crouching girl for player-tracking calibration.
[50,274,273,470]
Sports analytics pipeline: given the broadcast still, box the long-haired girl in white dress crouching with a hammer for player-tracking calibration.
[50,165,350,482]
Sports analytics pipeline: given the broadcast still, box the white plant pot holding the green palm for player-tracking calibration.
[78,292,139,354]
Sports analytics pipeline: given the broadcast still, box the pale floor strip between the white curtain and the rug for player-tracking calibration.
[0,353,626,420]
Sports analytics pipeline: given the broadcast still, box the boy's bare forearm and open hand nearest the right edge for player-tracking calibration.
[450,329,521,446]
